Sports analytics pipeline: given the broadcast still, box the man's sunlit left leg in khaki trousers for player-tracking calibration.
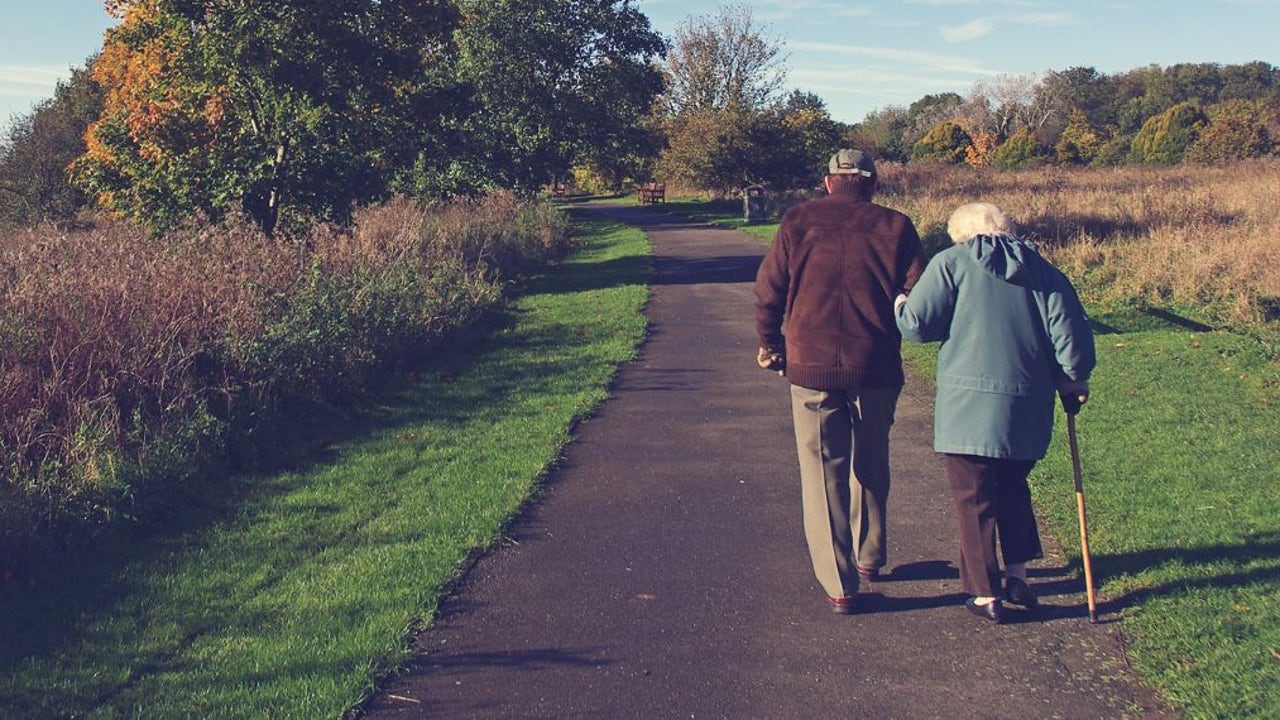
[791,386,858,597]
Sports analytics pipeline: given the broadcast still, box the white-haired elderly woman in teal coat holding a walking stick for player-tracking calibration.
[895,202,1094,623]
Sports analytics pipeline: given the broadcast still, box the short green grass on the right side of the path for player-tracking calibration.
[672,196,1280,720]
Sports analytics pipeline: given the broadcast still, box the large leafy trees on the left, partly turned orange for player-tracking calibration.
[0,0,664,233]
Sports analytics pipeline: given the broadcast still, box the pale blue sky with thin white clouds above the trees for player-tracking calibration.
[0,0,1280,131]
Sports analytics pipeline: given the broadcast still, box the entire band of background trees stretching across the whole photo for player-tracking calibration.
[0,0,1280,226]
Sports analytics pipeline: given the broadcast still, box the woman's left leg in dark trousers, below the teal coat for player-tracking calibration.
[945,455,1000,597]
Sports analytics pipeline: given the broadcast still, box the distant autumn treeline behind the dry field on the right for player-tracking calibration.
[849,61,1280,168]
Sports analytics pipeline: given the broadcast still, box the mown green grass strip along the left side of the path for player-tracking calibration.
[0,210,650,719]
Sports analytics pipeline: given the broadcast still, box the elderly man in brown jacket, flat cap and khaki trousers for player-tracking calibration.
[755,150,924,614]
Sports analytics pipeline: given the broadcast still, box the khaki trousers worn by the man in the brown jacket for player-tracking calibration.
[791,386,902,597]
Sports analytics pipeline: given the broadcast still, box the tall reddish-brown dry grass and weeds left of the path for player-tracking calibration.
[0,195,567,570]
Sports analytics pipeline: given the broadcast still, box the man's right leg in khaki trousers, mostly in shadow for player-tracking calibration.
[850,387,902,570]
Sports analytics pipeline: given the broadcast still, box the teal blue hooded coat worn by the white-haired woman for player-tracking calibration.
[896,234,1094,460]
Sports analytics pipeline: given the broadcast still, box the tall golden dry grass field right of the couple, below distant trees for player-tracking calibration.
[879,158,1280,323]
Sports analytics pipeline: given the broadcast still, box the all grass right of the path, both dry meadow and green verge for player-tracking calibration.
[669,164,1280,720]
